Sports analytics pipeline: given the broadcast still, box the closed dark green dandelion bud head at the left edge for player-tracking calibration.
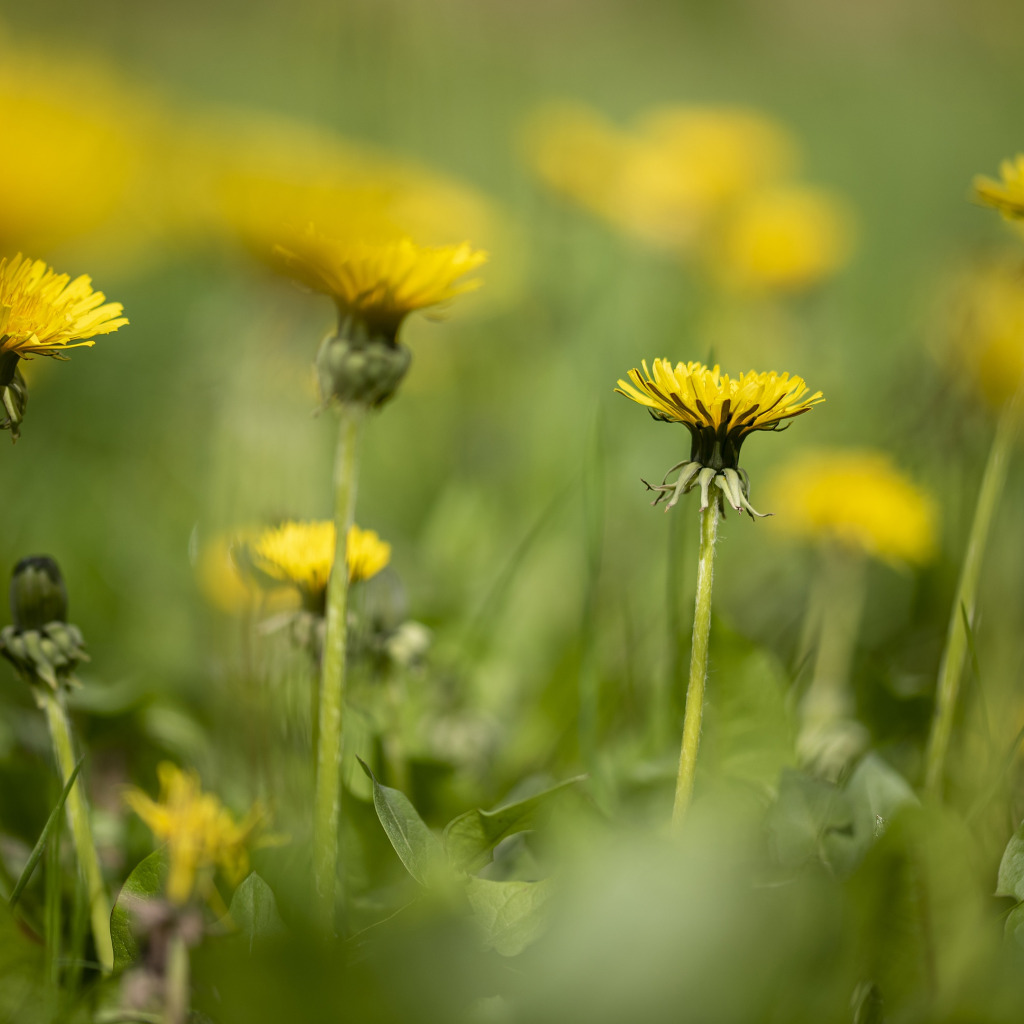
[0,555,89,690]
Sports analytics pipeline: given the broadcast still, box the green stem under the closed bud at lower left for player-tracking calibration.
[36,684,114,973]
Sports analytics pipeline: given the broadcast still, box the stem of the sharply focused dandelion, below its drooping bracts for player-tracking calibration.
[672,496,719,828]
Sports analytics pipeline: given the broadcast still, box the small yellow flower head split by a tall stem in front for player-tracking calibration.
[247,519,391,601]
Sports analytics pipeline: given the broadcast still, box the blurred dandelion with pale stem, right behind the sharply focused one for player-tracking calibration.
[771,449,938,779]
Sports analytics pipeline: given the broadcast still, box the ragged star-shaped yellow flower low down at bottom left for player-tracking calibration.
[124,761,264,905]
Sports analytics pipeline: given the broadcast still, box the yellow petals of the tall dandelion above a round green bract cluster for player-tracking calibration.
[275,228,487,339]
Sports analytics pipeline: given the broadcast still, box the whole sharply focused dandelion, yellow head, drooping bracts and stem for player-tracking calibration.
[615,359,824,827]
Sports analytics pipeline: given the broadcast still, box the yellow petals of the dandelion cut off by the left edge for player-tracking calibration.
[0,253,128,359]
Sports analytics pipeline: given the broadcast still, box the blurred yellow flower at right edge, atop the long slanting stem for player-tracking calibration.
[953,260,1024,408]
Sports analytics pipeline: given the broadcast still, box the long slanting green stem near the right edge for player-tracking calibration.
[925,388,1022,797]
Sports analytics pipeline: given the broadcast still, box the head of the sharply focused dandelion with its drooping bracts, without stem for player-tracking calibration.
[615,359,824,517]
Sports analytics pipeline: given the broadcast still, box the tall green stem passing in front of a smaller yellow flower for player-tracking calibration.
[313,403,362,934]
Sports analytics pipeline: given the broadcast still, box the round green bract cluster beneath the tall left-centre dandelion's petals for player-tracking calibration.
[316,312,413,409]
